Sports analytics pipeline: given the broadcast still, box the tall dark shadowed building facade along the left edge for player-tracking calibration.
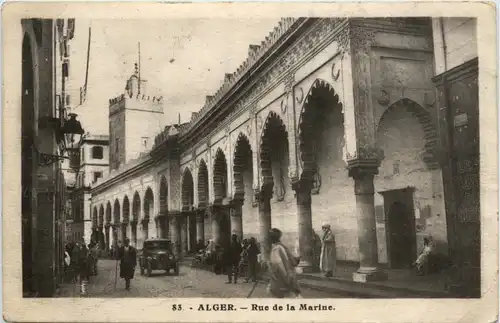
[19,19,75,297]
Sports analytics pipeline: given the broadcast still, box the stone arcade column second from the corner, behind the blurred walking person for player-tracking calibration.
[292,180,316,273]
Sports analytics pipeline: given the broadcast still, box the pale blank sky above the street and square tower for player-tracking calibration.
[69,18,279,134]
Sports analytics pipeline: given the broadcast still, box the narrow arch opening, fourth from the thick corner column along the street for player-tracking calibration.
[212,148,231,248]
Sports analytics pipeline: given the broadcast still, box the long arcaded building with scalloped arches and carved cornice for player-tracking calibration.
[91,18,480,294]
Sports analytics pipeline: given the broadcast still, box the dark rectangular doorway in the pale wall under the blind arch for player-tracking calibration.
[382,188,417,269]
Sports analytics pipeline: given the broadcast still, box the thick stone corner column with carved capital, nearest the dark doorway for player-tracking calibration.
[349,165,387,283]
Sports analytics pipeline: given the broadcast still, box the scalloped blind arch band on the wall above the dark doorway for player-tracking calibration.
[376,98,439,169]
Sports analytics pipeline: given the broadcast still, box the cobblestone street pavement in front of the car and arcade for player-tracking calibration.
[59,260,340,298]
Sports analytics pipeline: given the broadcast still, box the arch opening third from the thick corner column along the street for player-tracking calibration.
[231,134,252,239]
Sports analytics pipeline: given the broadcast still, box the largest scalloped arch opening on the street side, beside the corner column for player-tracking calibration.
[296,79,346,269]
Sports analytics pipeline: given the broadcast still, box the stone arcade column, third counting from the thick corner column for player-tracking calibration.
[254,186,272,260]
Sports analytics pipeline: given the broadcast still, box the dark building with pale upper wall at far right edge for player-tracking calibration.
[432,18,481,297]
